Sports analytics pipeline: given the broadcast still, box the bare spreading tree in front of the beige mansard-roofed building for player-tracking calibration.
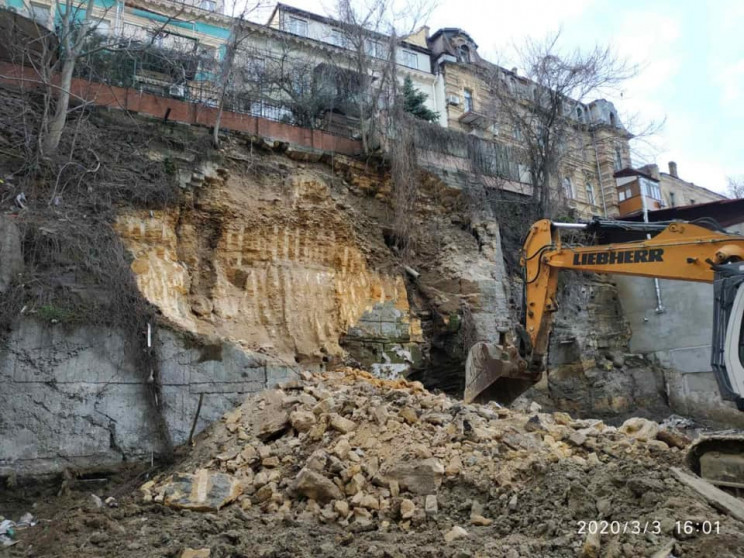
[489,33,635,217]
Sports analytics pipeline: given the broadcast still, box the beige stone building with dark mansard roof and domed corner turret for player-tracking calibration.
[428,28,632,216]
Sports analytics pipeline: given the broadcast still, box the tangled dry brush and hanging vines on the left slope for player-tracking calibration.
[0,85,192,462]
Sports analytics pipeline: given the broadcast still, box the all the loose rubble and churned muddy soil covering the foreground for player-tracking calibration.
[5,369,744,558]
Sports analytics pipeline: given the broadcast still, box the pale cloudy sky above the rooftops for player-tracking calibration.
[264,0,744,192]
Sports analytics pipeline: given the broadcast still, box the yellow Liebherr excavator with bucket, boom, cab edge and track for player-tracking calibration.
[464,219,744,488]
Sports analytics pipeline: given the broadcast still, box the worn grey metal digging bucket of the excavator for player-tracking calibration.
[464,342,542,405]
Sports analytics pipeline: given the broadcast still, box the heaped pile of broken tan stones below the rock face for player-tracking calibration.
[131,369,740,556]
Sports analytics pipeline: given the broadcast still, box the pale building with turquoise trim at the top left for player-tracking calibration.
[0,0,232,102]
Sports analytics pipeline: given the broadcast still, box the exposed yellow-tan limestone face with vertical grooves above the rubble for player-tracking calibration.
[116,169,421,370]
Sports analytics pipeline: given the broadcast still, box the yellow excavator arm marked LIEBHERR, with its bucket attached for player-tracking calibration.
[465,219,744,403]
